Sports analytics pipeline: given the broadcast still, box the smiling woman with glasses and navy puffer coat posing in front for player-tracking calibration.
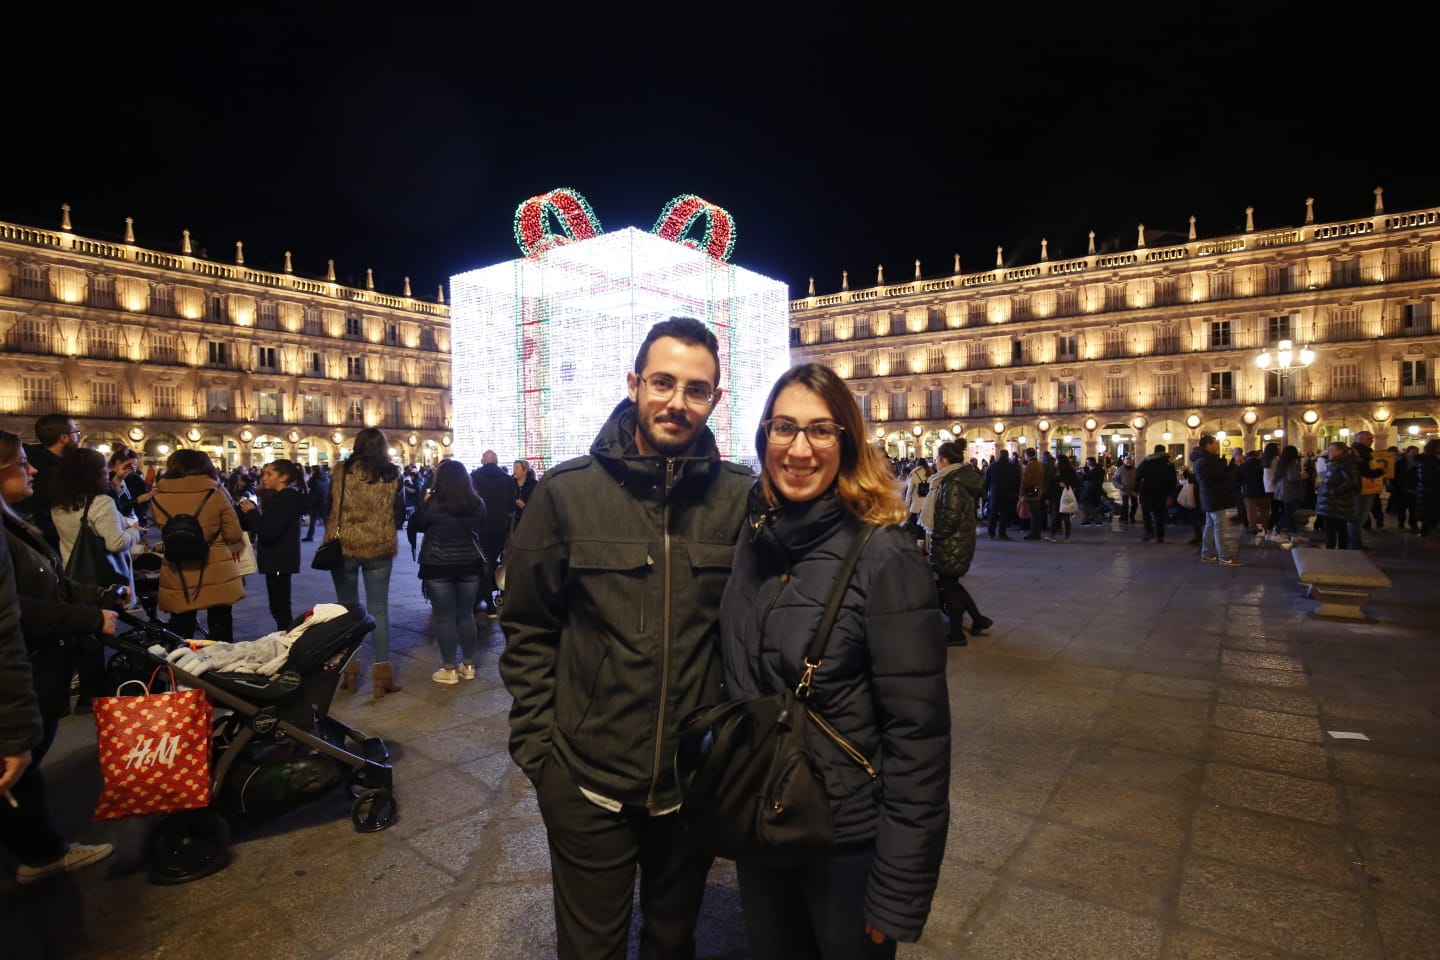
[720,364,950,960]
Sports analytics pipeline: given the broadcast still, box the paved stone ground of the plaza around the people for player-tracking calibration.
[0,528,1440,960]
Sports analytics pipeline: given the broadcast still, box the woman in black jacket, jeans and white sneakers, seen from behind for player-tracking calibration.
[409,461,485,684]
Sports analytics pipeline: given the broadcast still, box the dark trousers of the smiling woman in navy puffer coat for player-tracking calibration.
[734,846,896,960]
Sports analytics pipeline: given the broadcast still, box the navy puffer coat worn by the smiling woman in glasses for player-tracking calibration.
[717,484,950,940]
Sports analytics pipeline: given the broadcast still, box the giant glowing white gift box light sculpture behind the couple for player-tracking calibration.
[451,191,789,469]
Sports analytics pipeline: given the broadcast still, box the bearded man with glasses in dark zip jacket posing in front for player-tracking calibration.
[500,317,755,960]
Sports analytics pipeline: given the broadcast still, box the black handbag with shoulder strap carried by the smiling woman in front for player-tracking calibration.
[675,524,876,866]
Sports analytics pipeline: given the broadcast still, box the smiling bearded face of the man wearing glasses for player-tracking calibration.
[625,337,720,456]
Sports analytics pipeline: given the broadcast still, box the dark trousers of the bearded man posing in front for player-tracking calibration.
[536,759,713,960]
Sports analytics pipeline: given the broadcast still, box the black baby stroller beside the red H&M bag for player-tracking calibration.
[111,606,397,884]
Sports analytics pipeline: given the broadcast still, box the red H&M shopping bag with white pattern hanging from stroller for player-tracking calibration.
[91,668,213,820]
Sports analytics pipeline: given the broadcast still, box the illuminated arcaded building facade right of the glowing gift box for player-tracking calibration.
[791,190,1440,456]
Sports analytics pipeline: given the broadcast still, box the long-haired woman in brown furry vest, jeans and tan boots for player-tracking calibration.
[325,426,405,699]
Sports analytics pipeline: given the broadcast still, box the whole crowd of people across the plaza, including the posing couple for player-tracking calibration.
[0,341,1440,959]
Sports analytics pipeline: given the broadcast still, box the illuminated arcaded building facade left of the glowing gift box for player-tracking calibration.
[0,207,451,468]
